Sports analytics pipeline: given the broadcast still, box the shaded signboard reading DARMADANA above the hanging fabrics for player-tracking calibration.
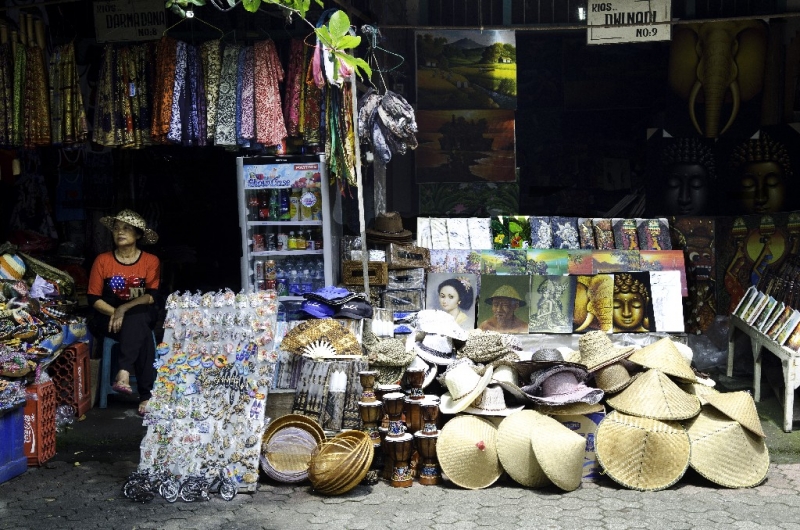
[93,0,167,42]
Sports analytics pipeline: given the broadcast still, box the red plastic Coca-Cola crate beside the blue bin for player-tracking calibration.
[24,381,56,466]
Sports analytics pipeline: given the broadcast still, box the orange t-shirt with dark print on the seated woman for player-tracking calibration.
[87,251,161,307]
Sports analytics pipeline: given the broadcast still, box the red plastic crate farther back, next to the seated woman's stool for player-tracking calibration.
[48,342,92,418]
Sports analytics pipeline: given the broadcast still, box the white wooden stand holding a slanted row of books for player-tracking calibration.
[728,315,800,432]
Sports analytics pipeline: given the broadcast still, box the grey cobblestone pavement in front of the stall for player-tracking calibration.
[0,461,800,530]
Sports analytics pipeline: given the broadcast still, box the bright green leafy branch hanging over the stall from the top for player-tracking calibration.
[164,0,372,79]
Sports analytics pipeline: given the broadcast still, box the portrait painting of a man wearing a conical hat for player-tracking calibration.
[478,274,530,333]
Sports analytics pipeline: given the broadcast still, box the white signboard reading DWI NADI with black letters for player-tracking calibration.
[586,0,672,44]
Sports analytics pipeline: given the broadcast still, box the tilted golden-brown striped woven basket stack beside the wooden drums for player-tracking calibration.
[308,430,375,495]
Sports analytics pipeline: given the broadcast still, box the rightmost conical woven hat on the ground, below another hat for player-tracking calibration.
[686,407,769,488]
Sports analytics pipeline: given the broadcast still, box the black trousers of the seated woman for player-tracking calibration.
[98,304,158,401]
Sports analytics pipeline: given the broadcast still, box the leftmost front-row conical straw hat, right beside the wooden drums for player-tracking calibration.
[436,414,500,489]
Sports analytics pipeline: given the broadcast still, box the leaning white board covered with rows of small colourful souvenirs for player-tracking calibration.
[139,290,277,491]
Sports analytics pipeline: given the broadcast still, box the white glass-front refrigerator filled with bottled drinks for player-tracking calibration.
[236,155,338,306]
